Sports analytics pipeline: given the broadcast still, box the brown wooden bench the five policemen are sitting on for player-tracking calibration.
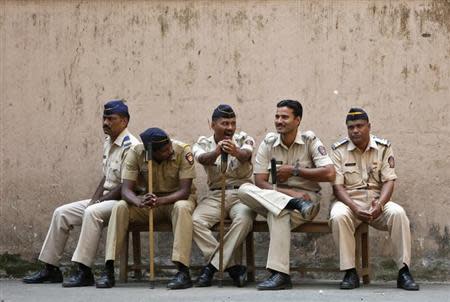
[119,221,370,284]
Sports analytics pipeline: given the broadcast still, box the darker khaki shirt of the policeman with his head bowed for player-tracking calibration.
[122,140,195,195]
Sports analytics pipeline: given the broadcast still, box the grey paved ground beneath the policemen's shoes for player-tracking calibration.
[0,280,450,302]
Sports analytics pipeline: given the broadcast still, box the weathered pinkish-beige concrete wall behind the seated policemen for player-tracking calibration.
[0,0,450,280]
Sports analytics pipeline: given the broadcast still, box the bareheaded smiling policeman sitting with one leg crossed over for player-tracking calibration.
[239,100,335,290]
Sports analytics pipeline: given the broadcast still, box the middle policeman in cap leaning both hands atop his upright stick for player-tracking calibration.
[193,105,255,287]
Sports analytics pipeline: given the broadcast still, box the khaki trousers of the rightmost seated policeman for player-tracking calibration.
[330,191,411,270]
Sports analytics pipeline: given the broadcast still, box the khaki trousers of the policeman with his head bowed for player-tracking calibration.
[105,195,195,266]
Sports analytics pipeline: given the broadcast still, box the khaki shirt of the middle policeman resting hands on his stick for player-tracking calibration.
[192,131,255,189]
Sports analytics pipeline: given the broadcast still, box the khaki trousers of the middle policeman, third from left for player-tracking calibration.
[192,190,256,269]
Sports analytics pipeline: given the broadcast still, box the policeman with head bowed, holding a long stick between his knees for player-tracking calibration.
[96,128,195,289]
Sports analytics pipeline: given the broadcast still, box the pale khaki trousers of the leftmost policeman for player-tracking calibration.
[39,199,117,267]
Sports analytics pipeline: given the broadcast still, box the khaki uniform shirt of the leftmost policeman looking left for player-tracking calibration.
[103,129,139,194]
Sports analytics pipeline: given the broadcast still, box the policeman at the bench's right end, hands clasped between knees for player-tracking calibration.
[330,108,419,290]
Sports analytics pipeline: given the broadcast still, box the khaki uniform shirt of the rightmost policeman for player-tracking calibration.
[331,135,397,196]
